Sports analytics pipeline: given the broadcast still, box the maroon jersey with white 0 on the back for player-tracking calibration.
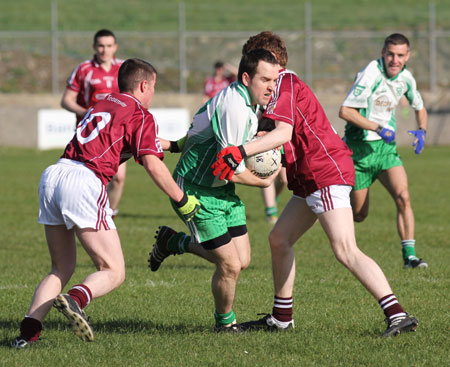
[61,93,164,185]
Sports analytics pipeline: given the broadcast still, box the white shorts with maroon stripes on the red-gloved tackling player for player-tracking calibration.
[294,185,352,214]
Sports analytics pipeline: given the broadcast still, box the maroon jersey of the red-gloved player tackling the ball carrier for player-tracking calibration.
[264,70,355,197]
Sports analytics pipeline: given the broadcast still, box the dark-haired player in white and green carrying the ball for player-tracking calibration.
[149,49,279,332]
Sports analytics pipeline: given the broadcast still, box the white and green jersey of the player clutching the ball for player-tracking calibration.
[175,82,258,187]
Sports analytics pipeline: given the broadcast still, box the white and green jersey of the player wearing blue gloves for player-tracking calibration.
[342,58,423,141]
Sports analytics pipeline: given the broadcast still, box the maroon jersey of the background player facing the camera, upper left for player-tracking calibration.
[67,57,123,119]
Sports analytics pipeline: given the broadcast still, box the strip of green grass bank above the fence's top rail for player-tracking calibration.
[0,0,450,32]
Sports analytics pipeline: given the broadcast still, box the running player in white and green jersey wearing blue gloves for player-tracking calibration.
[339,33,428,268]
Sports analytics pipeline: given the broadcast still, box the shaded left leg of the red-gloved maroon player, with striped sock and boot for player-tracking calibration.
[241,196,317,330]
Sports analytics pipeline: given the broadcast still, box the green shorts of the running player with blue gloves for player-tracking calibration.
[346,140,403,190]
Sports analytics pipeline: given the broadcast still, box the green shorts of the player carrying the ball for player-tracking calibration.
[175,177,246,243]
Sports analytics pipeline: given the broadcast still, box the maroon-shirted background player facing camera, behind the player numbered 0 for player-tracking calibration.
[61,29,127,215]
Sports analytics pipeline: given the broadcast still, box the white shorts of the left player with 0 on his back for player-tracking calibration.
[38,158,116,230]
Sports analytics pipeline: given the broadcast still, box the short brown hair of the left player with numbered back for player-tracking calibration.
[117,59,158,92]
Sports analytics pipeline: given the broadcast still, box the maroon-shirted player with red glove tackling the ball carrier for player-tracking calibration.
[212,32,418,336]
